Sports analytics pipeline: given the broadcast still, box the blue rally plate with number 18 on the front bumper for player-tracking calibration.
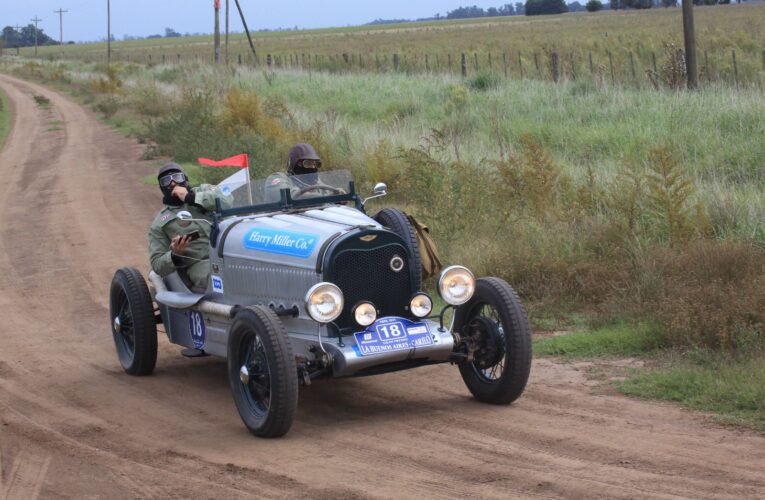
[354,318,433,356]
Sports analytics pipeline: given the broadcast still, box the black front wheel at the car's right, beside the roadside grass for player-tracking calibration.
[454,278,531,404]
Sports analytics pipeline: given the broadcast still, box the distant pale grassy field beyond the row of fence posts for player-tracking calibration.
[22,4,765,86]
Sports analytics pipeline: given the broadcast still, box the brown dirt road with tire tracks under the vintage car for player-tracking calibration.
[0,76,765,499]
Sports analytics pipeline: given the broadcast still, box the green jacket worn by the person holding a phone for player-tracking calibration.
[149,184,220,277]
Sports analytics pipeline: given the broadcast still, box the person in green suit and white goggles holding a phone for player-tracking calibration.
[149,163,220,292]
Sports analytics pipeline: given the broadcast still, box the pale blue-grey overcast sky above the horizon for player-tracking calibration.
[0,0,515,42]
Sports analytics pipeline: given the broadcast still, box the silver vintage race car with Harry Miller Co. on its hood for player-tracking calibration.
[110,171,531,437]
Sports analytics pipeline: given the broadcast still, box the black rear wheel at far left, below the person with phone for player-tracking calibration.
[109,267,157,376]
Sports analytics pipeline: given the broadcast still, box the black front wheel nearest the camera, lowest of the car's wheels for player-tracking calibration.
[228,306,298,438]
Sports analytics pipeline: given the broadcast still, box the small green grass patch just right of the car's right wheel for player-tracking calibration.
[534,323,663,358]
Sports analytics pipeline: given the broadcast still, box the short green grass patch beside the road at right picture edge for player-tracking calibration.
[617,354,765,431]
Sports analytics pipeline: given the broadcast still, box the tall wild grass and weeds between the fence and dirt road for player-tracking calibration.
[7,57,765,350]
